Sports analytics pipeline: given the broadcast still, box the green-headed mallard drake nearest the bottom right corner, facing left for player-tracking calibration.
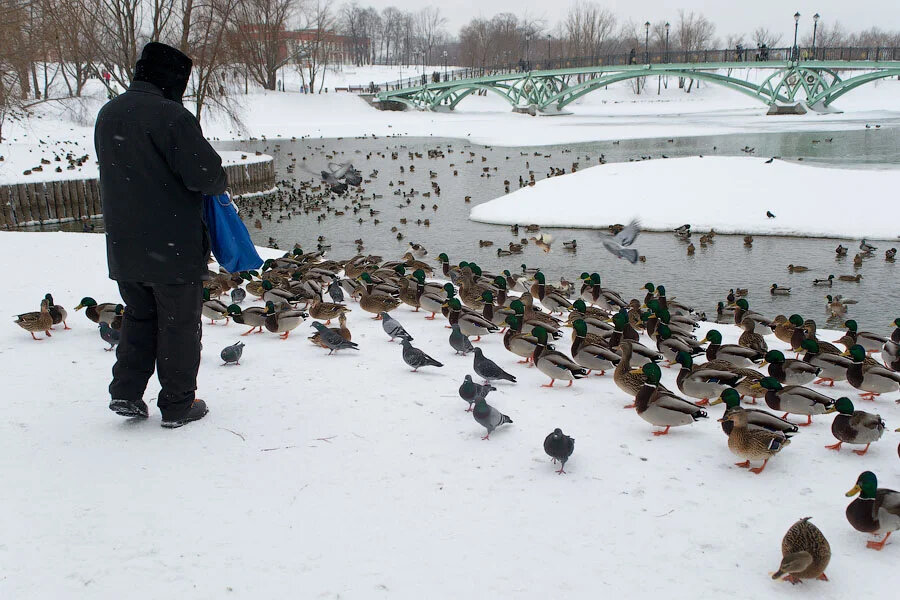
[847,471,900,550]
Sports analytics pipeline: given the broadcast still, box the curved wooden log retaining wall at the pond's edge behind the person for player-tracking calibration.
[0,159,275,229]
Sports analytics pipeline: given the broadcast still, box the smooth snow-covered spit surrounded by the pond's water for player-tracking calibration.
[470,157,900,240]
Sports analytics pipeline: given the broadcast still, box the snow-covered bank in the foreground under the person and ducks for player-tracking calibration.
[0,232,900,600]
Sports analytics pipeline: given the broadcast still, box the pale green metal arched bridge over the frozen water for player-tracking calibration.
[374,48,900,114]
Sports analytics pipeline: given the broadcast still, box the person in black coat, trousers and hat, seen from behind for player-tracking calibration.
[94,42,226,427]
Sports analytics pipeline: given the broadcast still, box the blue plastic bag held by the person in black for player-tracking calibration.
[203,193,263,273]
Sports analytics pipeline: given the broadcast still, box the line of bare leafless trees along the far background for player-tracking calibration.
[0,0,900,138]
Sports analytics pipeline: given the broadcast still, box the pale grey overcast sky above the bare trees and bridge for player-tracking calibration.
[368,0,900,39]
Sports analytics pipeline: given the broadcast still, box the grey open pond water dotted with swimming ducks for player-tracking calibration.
[24,128,900,333]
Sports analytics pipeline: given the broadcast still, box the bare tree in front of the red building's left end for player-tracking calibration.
[230,0,297,90]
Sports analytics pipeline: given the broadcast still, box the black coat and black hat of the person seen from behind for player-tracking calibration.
[94,42,226,284]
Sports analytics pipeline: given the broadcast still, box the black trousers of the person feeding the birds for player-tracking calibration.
[109,281,203,419]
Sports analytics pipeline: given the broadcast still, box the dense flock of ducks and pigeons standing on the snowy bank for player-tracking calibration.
[16,232,900,582]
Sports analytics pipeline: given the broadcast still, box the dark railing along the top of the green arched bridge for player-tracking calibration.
[366,47,900,93]
